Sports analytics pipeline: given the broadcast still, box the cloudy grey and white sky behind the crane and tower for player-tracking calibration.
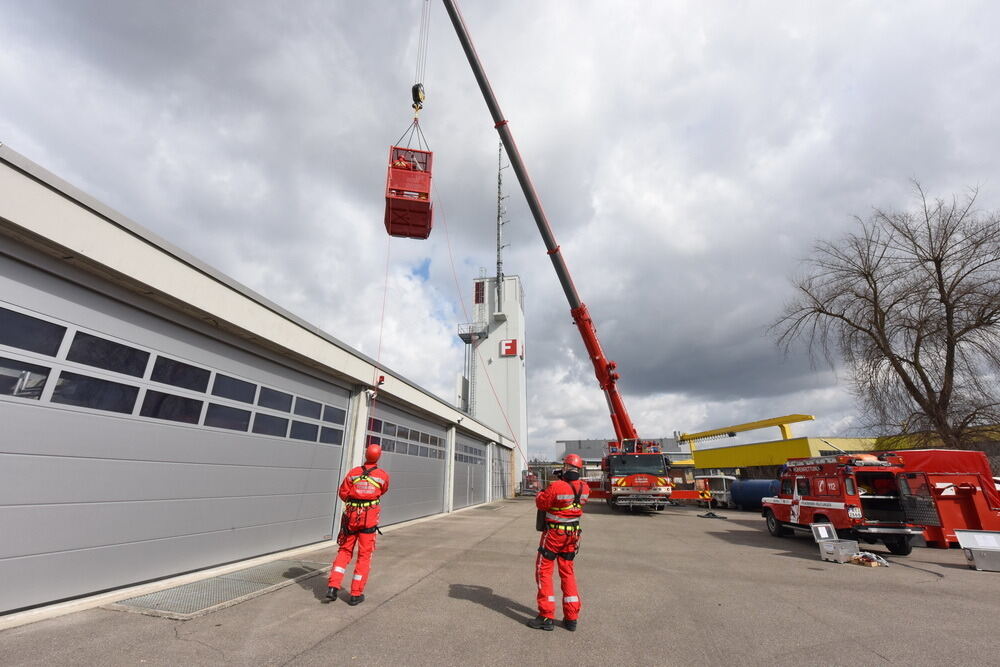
[0,0,1000,457]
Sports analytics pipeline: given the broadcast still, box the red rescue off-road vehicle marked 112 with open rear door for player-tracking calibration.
[761,454,937,556]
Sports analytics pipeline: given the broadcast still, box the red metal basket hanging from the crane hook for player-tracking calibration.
[385,146,434,239]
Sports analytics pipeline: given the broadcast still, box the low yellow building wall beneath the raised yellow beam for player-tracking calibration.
[694,438,877,469]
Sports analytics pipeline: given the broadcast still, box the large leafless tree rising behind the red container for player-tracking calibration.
[771,183,1000,447]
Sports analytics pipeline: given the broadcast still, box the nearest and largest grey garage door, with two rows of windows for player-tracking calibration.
[0,255,349,611]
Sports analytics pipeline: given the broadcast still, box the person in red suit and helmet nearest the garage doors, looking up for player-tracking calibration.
[326,445,389,606]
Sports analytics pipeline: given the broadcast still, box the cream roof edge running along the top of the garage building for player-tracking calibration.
[0,144,514,447]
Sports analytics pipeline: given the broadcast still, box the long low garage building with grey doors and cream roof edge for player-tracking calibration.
[0,146,514,613]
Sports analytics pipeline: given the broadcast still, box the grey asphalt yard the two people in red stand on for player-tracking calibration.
[0,498,1000,667]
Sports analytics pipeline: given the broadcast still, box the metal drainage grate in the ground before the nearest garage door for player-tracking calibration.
[108,560,329,620]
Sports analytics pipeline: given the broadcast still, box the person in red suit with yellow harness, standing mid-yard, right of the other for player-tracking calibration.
[528,454,590,630]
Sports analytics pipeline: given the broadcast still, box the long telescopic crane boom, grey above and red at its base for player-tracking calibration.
[443,0,638,445]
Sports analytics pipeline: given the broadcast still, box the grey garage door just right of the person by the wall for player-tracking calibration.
[367,402,445,525]
